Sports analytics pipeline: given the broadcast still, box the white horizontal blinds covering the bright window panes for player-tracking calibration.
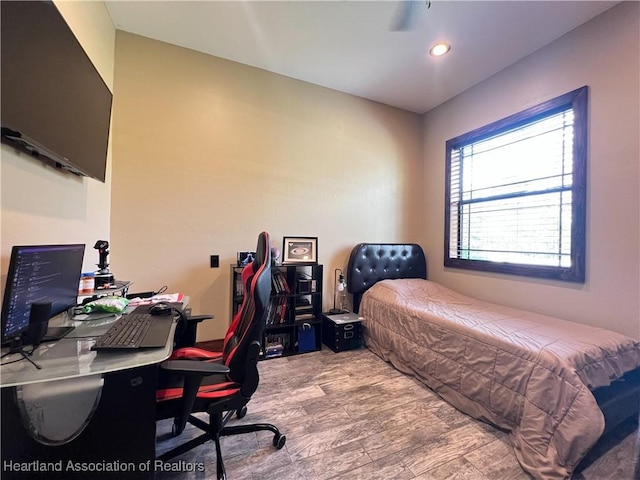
[448,109,574,267]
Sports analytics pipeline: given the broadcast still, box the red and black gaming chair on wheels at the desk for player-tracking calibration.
[157,232,286,479]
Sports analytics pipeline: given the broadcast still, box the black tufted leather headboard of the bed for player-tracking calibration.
[347,243,427,313]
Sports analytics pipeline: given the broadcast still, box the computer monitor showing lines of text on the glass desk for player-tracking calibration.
[2,244,85,343]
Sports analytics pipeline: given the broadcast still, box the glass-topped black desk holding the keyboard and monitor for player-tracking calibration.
[0,317,175,480]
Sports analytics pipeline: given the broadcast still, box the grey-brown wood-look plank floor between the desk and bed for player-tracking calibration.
[156,347,640,480]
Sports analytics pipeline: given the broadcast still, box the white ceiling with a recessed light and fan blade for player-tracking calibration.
[105,0,618,113]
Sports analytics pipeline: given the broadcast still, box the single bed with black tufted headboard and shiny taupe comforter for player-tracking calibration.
[347,243,640,479]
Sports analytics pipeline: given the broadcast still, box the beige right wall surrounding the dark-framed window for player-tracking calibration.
[424,2,640,338]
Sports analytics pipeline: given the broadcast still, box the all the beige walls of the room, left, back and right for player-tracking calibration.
[0,1,640,339]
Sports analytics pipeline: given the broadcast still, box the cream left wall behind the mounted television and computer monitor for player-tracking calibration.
[0,1,115,288]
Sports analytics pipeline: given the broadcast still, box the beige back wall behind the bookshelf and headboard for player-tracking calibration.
[111,31,424,340]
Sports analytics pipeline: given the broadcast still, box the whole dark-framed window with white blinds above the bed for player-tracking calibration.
[444,86,588,282]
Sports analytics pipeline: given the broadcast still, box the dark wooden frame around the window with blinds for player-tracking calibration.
[444,86,588,283]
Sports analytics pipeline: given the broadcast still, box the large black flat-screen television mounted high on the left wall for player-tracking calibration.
[0,0,112,182]
